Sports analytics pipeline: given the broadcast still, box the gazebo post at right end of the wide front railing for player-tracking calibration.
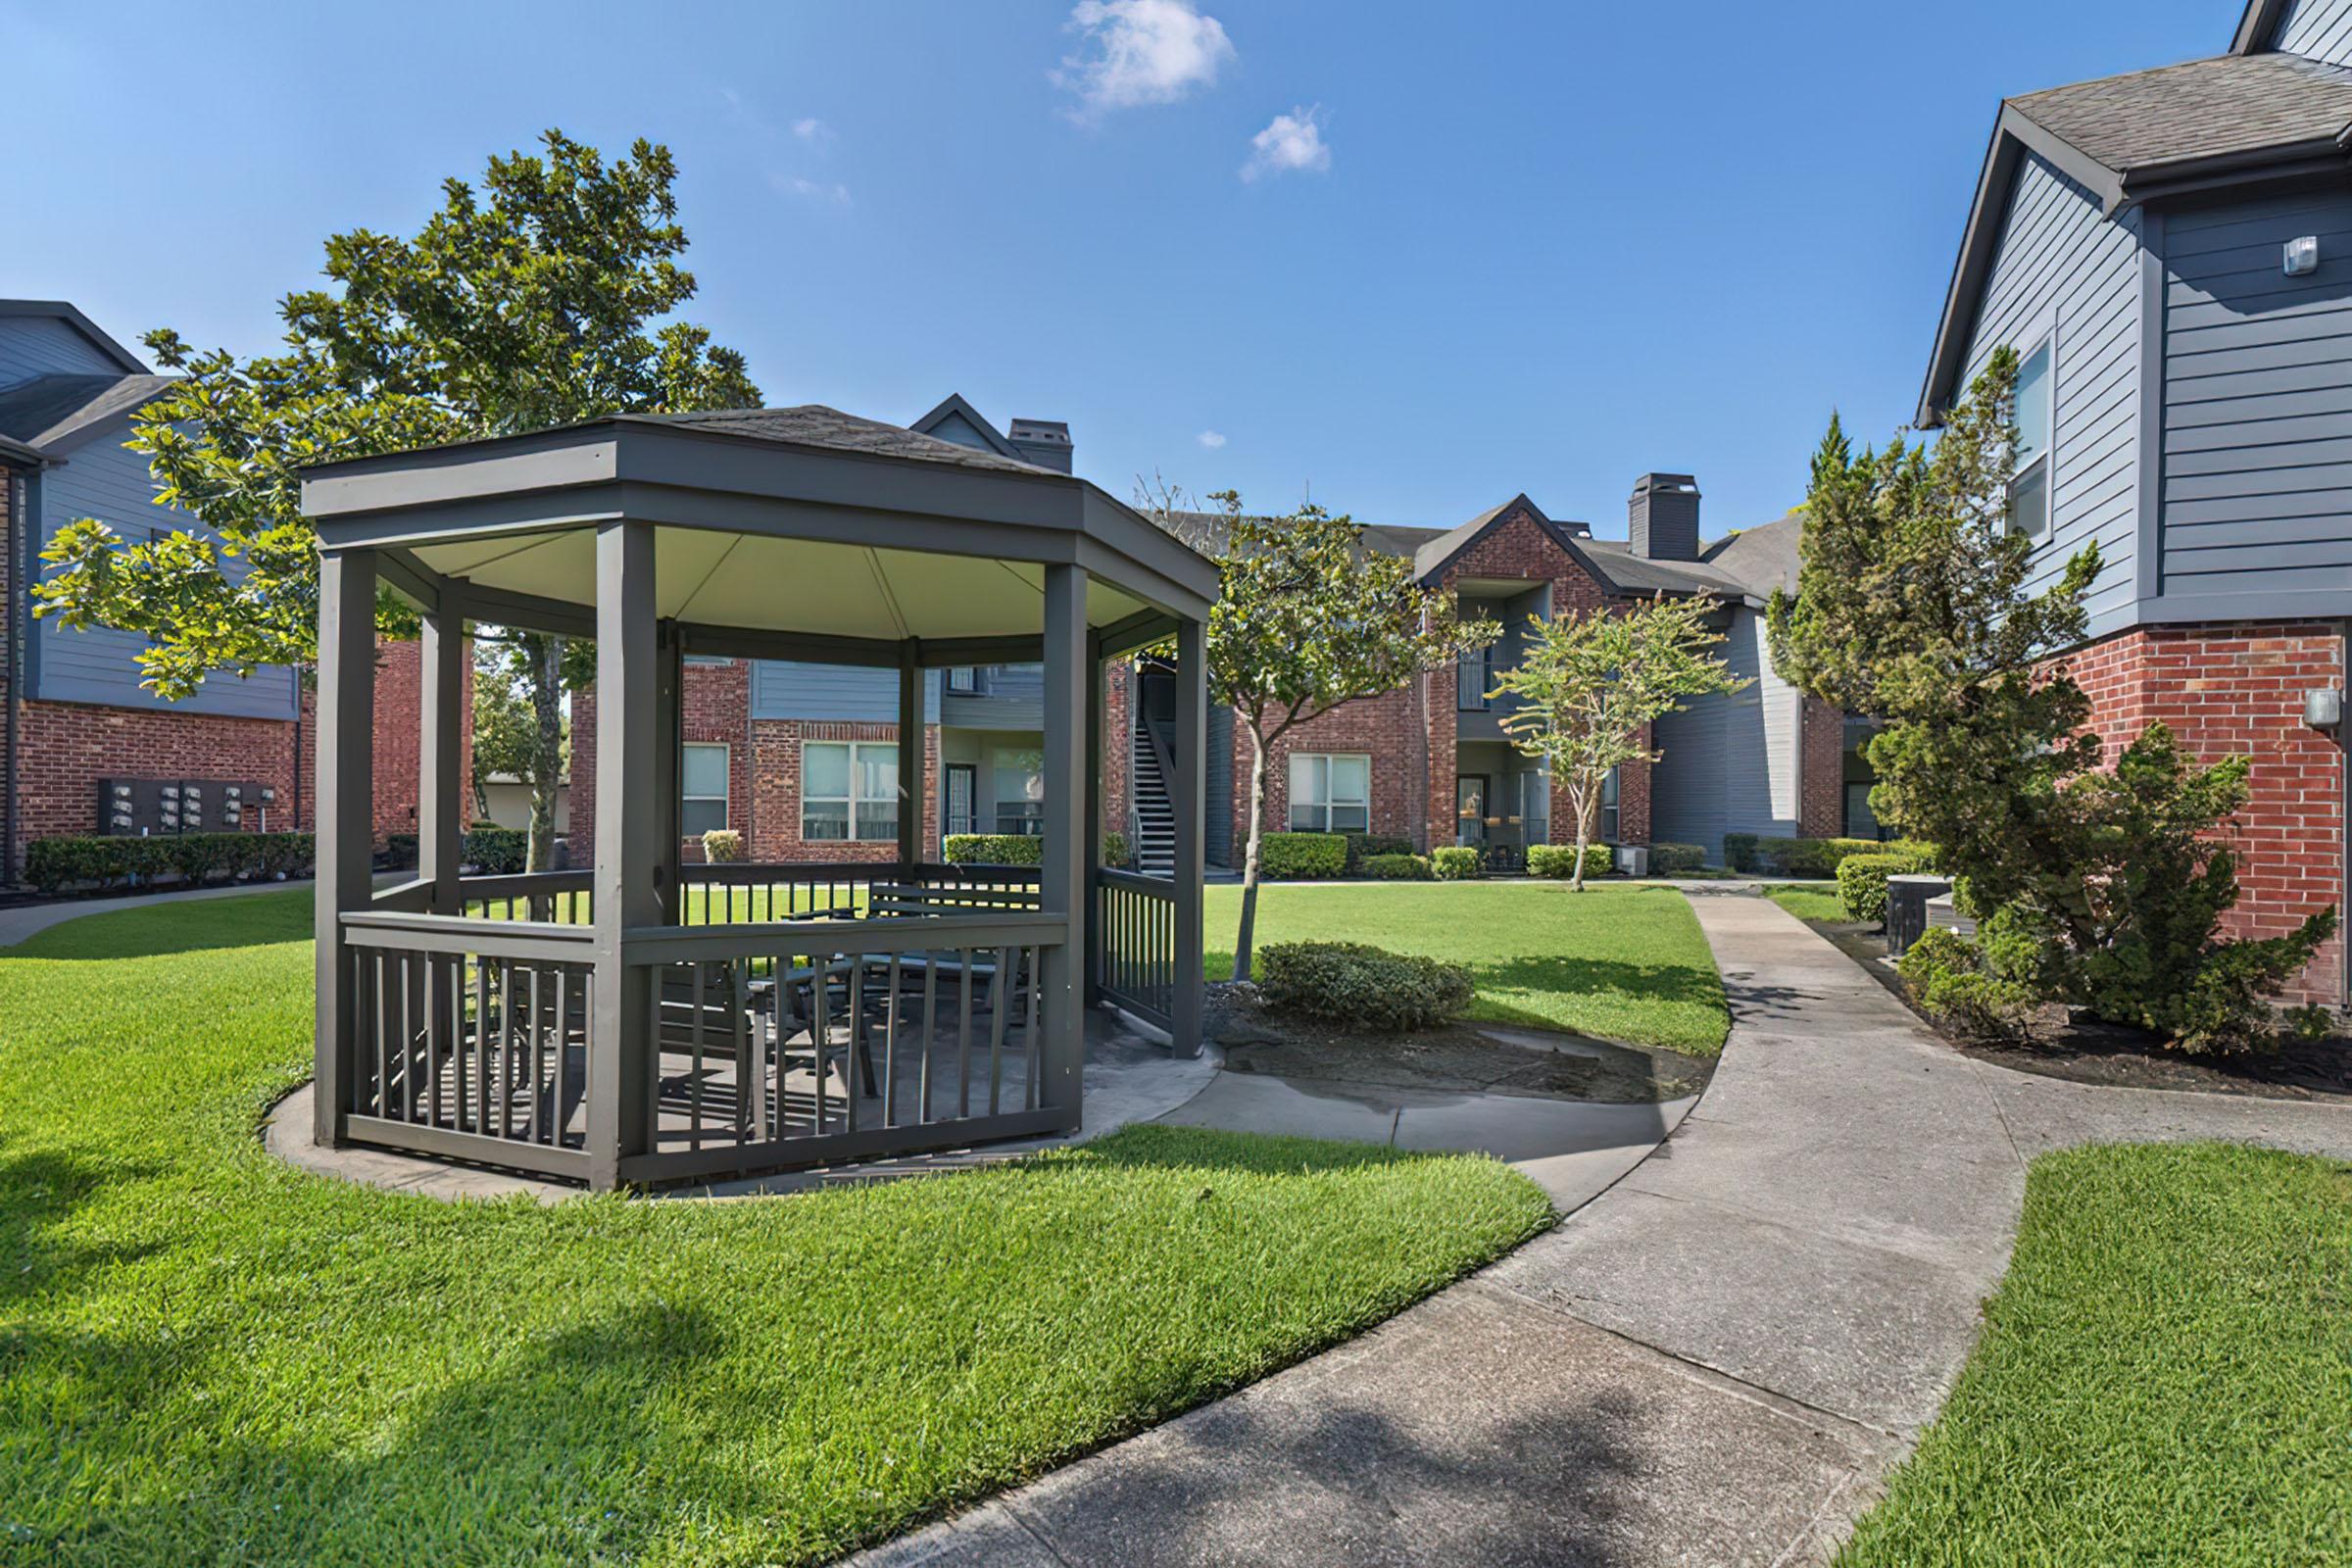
[1030,566,1092,1126]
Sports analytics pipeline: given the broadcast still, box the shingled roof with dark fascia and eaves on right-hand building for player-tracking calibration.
[1917,17,2352,428]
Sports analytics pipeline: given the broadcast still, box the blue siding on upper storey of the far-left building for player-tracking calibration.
[31,420,299,719]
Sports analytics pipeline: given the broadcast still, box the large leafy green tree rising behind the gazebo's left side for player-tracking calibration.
[33,131,760,867]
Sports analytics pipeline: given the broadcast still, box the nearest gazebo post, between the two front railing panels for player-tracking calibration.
[588,522,668,1192]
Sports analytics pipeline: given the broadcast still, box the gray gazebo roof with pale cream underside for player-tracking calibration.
[304,405,1218,656]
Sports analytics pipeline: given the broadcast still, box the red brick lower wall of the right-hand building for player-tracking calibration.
[2063,620,2347,1004]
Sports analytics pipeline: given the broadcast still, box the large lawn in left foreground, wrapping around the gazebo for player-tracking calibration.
[0,894,1550,1568]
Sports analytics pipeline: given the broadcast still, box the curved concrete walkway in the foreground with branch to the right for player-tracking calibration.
[860,896,2352,1568]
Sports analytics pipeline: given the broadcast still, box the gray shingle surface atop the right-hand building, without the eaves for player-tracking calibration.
[2009,54,2352,174]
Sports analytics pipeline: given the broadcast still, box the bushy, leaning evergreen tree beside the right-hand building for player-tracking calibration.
[1769,348,2335,1049]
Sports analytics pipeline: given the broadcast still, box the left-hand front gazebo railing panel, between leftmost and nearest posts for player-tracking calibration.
[343,912,595,1178]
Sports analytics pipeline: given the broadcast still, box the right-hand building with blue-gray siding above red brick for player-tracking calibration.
[1919,0,2352,1004]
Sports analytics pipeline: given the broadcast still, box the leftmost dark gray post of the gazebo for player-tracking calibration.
[311,550,376,1148]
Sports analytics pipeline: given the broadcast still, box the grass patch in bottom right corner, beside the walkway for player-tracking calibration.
[1837,1145,2352,1568]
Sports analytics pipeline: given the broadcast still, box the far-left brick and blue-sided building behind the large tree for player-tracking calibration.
[0,301,442,884]
